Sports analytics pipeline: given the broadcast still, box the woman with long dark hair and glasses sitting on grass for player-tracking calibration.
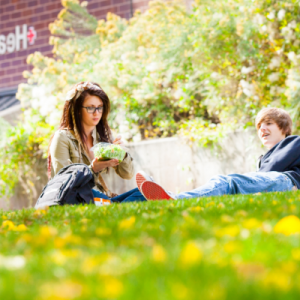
[48,82,145,202]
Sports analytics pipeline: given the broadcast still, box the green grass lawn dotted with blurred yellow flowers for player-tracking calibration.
[0,192,300,300]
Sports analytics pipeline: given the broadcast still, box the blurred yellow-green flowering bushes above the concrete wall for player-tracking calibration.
[0,0,300,198]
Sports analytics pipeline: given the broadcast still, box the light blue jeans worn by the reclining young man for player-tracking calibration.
[175,172,294,199]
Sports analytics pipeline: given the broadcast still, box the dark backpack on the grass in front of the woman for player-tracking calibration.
[35,164,95,209]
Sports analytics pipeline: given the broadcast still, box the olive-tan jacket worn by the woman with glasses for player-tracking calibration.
[50,128,134,183]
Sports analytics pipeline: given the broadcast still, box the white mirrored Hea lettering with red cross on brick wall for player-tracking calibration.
[0,24,37,55]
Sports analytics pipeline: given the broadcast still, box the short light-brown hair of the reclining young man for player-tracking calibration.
[255,107,293,136]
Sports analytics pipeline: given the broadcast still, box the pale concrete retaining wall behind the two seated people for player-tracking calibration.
[0,132,265,209]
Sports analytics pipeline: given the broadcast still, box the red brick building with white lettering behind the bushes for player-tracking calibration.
[0,0,149,124]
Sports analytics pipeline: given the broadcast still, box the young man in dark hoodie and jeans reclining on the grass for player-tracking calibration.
[136,108,300,200]
